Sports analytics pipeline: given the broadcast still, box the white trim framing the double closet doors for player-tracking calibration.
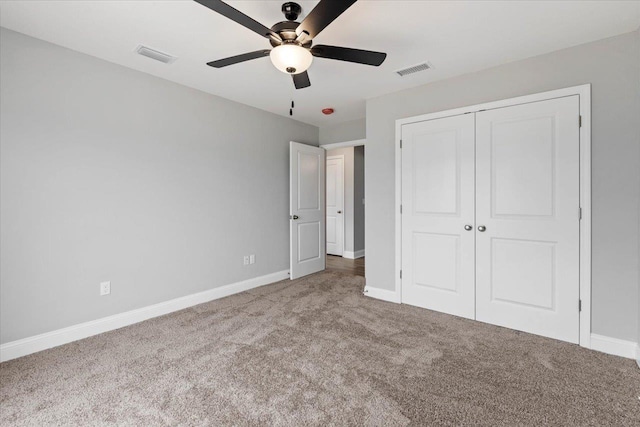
[395,84,591,348]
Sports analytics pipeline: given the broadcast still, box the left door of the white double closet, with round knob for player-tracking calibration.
[402,114,475,318]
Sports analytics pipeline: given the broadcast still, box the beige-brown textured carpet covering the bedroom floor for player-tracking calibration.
[0,272,640,426]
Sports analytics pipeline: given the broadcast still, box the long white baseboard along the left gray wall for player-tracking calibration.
[0,270,289,362]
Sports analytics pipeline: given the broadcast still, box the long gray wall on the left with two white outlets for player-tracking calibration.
[0,29,319,343]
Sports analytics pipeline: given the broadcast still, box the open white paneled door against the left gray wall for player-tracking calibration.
[289,142,326,279]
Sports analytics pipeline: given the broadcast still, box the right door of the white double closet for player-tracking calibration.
[476,96,580,343]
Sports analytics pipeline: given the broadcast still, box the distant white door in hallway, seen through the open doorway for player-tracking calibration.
[327,156,344,256]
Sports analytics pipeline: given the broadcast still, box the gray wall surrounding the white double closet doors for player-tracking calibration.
[366,31,640,341]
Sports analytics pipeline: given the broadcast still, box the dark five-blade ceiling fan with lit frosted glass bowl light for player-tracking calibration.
[195,0,387,89]
